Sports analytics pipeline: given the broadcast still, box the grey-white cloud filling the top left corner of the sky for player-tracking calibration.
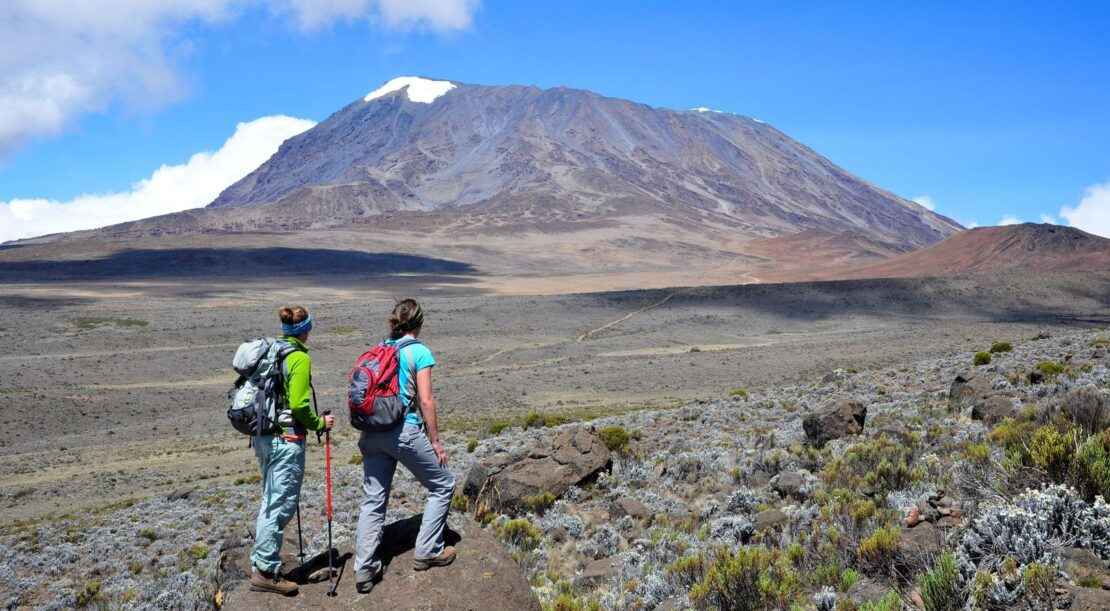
[0,0,478,157]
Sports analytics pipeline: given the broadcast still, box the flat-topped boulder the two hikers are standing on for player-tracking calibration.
[216,514,539,611]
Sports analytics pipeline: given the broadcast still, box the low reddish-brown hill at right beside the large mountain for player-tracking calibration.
[837,223,1110,278]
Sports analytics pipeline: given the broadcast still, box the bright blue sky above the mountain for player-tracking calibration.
[0,0,1110,239]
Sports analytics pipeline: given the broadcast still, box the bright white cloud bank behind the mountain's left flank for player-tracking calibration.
[0,116,315,242]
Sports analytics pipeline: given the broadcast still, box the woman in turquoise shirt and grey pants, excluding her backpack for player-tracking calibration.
[354,299,455,593]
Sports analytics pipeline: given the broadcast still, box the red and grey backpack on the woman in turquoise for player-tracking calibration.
[347,340,420,431]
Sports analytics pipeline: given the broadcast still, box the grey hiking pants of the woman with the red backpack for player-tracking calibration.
[354,422,455,581]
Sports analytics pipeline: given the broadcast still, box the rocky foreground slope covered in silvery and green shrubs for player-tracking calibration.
[0,331,1110,611]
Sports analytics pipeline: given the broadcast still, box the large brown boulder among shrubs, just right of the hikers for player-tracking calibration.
[463,427,612,513]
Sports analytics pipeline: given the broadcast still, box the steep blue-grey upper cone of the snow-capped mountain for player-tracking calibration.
[202,77,960,251]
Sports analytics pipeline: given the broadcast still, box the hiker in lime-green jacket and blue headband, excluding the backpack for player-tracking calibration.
[251,306,335,595]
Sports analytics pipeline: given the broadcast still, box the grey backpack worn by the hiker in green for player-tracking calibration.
[228,338,299,437]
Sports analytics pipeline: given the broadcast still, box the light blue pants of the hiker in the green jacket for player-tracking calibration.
[251,435,304,573]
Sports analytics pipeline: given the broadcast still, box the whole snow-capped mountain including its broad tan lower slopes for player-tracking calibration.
[0,77,981,292]
